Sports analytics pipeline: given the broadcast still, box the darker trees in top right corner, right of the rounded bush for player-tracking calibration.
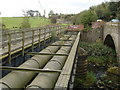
[92,1,120,21]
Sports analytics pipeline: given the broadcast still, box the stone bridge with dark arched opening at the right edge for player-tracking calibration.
[103,23,120,65]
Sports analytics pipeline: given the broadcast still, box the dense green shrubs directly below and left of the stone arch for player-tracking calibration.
[80,42,117,67]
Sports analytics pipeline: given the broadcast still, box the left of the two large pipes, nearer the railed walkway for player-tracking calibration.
[0,35,70,88]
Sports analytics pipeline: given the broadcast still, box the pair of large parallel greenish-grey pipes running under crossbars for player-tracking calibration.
[0,35,76,90]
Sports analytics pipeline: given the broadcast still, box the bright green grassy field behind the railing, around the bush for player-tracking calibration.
[2,17,50,29]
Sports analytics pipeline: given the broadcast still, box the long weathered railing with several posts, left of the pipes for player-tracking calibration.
[0,25,64,62]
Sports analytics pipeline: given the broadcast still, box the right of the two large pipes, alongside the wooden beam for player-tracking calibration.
[27,36,75,90]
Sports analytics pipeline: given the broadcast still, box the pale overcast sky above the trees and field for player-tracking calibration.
[0,0,109,17]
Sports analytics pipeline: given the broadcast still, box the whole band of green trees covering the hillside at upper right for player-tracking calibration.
[73,1,120,27]
